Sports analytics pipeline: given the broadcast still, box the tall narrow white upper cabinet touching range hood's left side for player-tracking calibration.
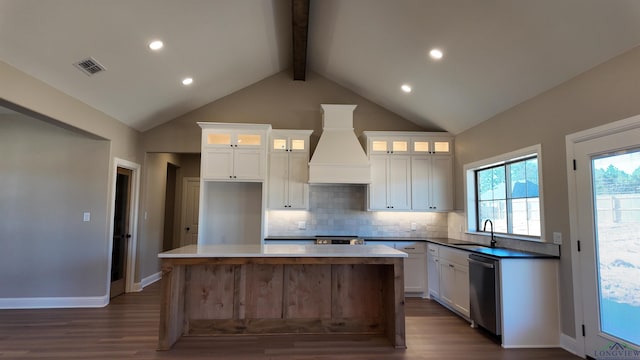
[268,130,313,209]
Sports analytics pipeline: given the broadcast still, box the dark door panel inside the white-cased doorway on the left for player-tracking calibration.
[109,167,133,298]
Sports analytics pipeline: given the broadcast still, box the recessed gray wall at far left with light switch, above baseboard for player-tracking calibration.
[0,115,109,298]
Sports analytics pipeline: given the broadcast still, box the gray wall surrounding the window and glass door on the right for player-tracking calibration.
[455,48,640,336]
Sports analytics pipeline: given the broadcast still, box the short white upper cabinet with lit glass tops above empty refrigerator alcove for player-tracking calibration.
[198,123,271,181]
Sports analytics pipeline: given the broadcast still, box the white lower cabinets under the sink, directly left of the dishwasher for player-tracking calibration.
[427,244,470,318]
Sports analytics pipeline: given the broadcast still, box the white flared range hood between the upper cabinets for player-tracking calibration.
[309,104,371,184]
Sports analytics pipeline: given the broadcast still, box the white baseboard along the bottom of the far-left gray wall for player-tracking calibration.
[0,295,109,309]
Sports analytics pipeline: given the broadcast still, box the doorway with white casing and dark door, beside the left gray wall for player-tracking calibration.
[108,158,140,299]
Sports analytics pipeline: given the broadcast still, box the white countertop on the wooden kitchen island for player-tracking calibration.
[158,244,408,258]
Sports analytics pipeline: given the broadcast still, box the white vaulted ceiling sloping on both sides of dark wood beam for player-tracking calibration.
[0,0,640,134]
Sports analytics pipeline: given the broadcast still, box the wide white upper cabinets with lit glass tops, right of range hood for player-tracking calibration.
[362,131,453,211]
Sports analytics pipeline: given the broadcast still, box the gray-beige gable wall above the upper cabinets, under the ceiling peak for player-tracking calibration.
[142,70,428,153]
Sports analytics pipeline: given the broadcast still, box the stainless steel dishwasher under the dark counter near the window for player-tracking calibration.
[469,254,502,335]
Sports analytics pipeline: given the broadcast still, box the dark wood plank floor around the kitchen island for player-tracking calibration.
[0,283,579,360]
